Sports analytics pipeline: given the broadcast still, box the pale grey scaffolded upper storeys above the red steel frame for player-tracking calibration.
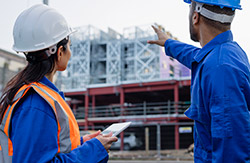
[56,25,190,91]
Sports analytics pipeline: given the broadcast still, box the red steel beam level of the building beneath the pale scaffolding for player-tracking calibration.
[65,80,192,149]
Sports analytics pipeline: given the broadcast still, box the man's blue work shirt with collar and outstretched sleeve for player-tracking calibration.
[165,30,250,163]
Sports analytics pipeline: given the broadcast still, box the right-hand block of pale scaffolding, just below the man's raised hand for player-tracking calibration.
[122,26,161,83]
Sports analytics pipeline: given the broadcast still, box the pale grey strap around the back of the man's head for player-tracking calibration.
[195,2,235,23]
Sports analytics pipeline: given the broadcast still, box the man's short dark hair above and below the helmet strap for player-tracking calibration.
[201,4,235,31]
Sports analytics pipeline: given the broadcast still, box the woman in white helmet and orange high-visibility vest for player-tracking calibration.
[0,5,117,163]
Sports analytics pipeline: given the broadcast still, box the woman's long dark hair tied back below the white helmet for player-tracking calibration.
[0,37,68,122]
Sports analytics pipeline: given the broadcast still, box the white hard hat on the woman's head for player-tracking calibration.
[13,4,73,53]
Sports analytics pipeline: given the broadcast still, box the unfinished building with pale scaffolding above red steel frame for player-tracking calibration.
[56,25,193,149]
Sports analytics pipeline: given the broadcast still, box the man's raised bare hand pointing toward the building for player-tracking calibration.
[148,25,170,46]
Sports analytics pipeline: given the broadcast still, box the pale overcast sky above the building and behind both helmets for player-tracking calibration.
[0,0,250,58]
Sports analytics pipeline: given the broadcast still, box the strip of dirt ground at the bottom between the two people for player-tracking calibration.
[109,149,193,161]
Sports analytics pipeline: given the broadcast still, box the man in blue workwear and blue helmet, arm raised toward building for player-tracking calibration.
[148,0,250,163]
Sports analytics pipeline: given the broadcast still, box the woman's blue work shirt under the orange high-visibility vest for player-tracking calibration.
[10,77,108,163]
